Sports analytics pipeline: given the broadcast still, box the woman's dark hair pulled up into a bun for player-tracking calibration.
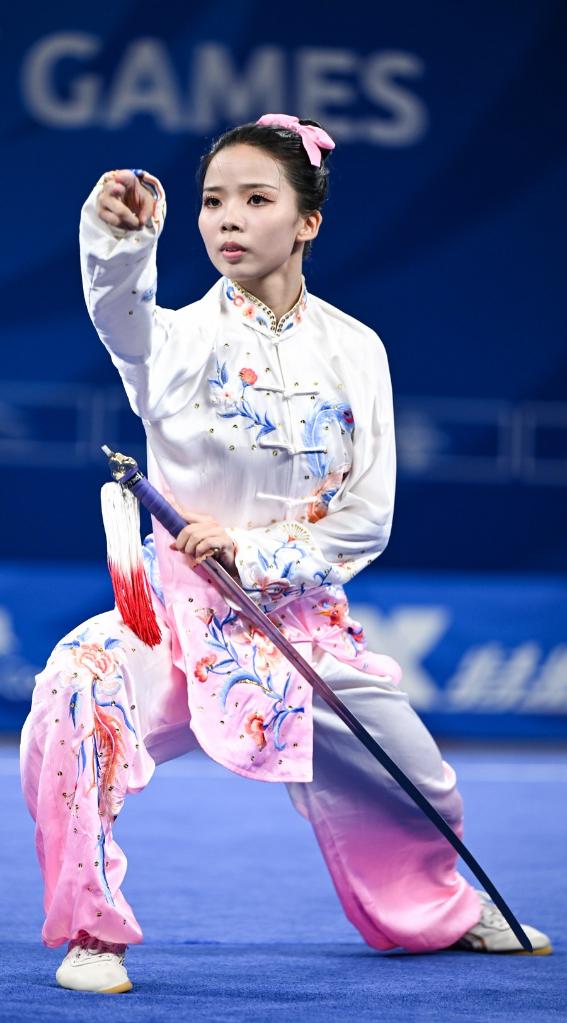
[197,120,331,258]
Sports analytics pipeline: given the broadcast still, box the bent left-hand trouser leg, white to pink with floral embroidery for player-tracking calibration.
[21,611,195,946]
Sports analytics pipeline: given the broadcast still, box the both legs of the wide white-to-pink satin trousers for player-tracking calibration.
[17,611,480,951]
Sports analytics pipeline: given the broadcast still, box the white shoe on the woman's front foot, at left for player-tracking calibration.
[55,938,133,994]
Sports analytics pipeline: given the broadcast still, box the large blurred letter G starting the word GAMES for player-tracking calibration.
[21,32,100,128]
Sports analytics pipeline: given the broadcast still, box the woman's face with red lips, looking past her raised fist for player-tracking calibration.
[199,143,320,282]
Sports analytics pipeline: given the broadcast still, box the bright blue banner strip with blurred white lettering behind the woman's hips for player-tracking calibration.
[0,563,567,740]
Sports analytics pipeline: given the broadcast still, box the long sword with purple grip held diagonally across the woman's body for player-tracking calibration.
[102,444,533,952]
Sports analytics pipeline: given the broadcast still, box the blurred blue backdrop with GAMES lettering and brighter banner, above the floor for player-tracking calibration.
[0,0,567,742]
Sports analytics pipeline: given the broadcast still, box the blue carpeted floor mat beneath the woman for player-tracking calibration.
[0,746,567,1023]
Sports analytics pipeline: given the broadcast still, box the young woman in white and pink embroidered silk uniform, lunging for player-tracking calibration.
[21,115,550,991]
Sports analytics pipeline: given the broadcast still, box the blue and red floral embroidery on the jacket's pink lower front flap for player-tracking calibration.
[194,609,305,750]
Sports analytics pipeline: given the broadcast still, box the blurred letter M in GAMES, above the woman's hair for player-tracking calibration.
[188,43,285,132]
